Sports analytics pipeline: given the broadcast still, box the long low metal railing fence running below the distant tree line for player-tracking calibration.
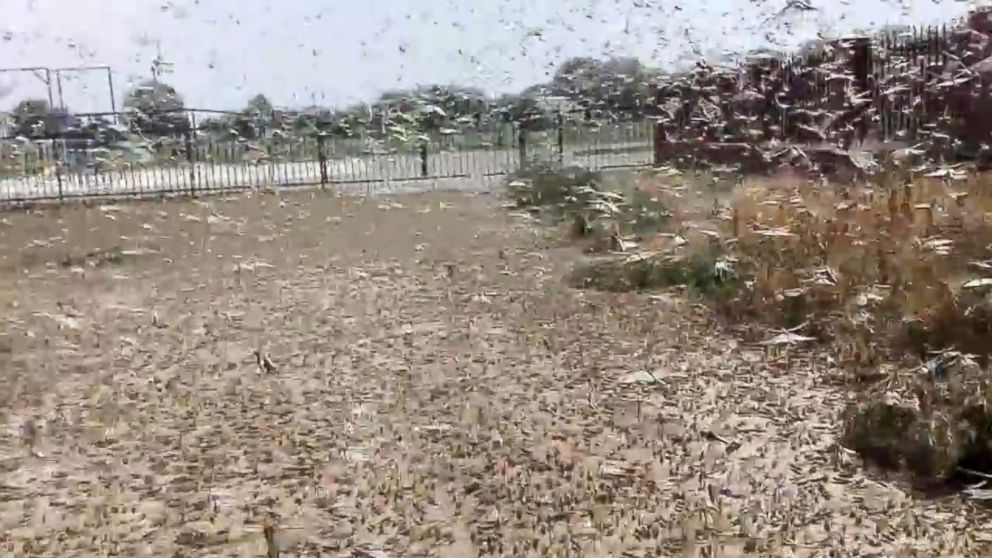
[0,121,653,205]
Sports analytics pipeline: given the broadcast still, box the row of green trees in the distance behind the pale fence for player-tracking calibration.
[1,57,662,144]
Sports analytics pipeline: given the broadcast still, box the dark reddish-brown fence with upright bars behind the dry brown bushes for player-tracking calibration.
[658,21,992,152]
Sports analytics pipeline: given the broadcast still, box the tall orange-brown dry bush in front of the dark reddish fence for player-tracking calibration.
[717,173,992,372]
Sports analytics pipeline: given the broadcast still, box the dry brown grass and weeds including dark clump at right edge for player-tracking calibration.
[564,170,992,486]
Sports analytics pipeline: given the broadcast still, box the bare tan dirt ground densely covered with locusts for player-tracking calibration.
[0,193,992,558]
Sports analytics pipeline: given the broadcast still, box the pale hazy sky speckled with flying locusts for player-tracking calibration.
[0,0,969,111]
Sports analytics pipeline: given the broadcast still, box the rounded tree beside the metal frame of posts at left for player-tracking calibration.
[124,80,189,136]
